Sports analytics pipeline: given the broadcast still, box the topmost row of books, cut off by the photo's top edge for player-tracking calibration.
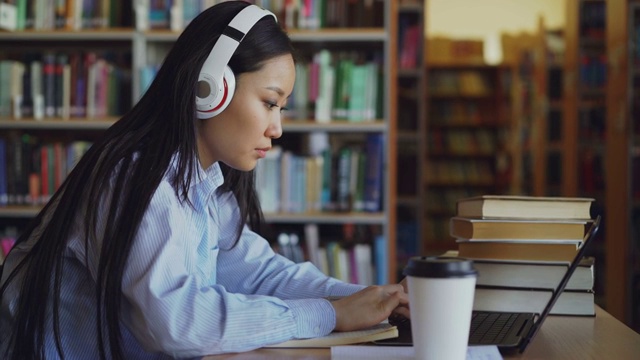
[6,0,384,31]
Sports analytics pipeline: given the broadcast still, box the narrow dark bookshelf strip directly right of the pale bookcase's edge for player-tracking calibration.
[396,0,427,273]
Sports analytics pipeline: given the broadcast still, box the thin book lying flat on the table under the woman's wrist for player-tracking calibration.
[267,322,398,348]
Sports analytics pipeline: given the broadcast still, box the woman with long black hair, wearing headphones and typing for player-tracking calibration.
[0,2,408,359]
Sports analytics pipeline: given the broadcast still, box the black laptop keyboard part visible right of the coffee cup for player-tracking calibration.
[469,312,518,344]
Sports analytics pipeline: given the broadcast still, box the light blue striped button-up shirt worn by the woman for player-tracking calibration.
[0,163,362,359]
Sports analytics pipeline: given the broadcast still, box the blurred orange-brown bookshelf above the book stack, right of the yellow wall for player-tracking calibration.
[512,17,564,196]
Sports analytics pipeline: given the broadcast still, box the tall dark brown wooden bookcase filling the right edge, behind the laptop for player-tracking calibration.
[560,0,640,331]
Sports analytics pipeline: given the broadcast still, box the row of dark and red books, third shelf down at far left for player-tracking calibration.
[0,134,91,206]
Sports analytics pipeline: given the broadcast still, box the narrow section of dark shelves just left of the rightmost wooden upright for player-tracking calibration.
[557,0,616,318]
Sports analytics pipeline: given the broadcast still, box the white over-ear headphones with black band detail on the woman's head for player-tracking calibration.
[196,5,278,119]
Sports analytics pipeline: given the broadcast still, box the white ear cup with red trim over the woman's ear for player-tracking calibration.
[196,66,236,119]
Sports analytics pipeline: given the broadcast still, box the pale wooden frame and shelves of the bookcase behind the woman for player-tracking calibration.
[0,0,398,282]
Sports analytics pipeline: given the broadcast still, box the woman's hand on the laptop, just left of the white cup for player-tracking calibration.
[331,284,409,331]
